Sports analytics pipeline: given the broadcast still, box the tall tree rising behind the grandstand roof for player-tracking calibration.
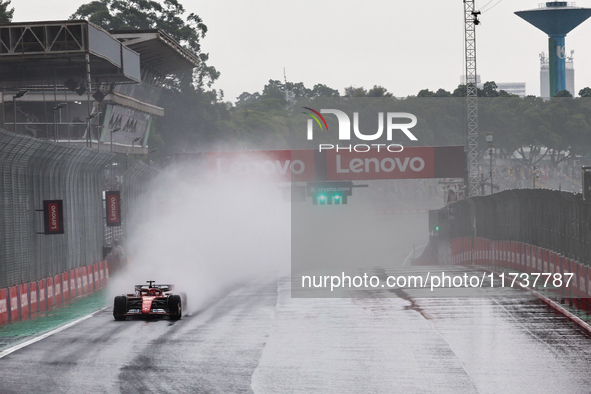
[70,0,219,91]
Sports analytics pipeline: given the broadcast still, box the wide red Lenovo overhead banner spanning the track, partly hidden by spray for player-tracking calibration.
[185,144,466,182]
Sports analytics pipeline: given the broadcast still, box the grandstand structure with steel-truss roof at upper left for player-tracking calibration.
[0,20,199,155]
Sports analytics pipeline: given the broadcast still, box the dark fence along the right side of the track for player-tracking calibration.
[449,189,591,266]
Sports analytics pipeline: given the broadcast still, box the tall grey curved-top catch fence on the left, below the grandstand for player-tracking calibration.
[0,130,111,288]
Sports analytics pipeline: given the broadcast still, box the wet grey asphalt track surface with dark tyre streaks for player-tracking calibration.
[0,279,591,393]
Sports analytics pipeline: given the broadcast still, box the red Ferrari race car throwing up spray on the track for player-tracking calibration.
[113,280,186,320]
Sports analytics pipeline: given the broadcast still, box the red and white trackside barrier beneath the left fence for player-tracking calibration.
[0,262,109,326]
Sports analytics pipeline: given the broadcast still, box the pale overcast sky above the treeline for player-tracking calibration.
[11,0,591,101]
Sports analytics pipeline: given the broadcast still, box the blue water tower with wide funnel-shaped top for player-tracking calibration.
[515,1,591,97]
